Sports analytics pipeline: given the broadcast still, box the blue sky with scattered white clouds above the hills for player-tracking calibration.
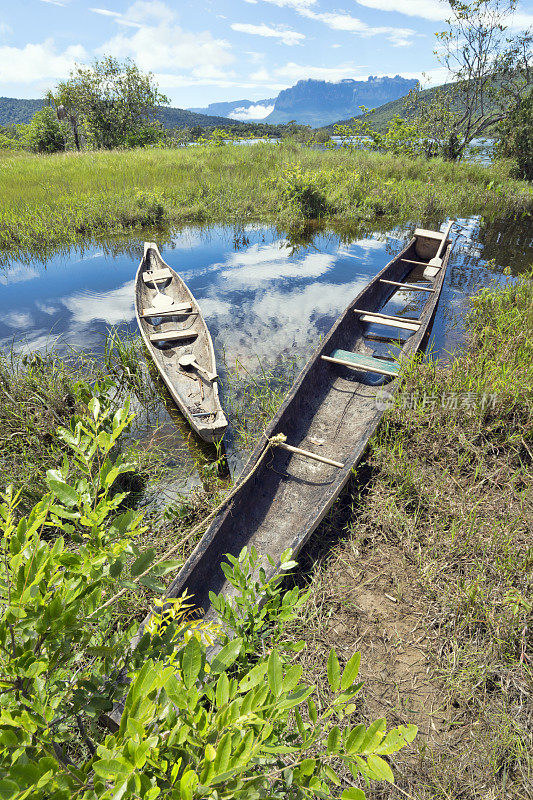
[0,0,533,115]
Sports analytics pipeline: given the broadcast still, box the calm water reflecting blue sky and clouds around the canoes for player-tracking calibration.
[0,218,533,494]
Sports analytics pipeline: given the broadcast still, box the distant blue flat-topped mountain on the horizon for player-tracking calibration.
[263,75,418,128]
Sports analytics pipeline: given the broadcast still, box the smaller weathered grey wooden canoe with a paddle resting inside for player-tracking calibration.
[135,242,228,442]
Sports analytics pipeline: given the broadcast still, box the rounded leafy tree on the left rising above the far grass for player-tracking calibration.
[54,56,169,149]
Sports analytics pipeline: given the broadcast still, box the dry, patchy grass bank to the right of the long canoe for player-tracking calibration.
[290,272,533,800]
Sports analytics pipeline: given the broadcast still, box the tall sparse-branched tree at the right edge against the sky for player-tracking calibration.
[428,0,533,160]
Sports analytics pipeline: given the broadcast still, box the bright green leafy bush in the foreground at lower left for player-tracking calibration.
[0,390,416,800]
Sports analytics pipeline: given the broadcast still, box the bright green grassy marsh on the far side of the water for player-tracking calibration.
[0,143,533,253]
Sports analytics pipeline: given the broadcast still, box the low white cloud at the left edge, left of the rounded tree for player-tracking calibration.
[0,39,87,83]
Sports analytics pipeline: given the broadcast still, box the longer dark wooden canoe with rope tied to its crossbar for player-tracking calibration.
[159,228,451,612]
